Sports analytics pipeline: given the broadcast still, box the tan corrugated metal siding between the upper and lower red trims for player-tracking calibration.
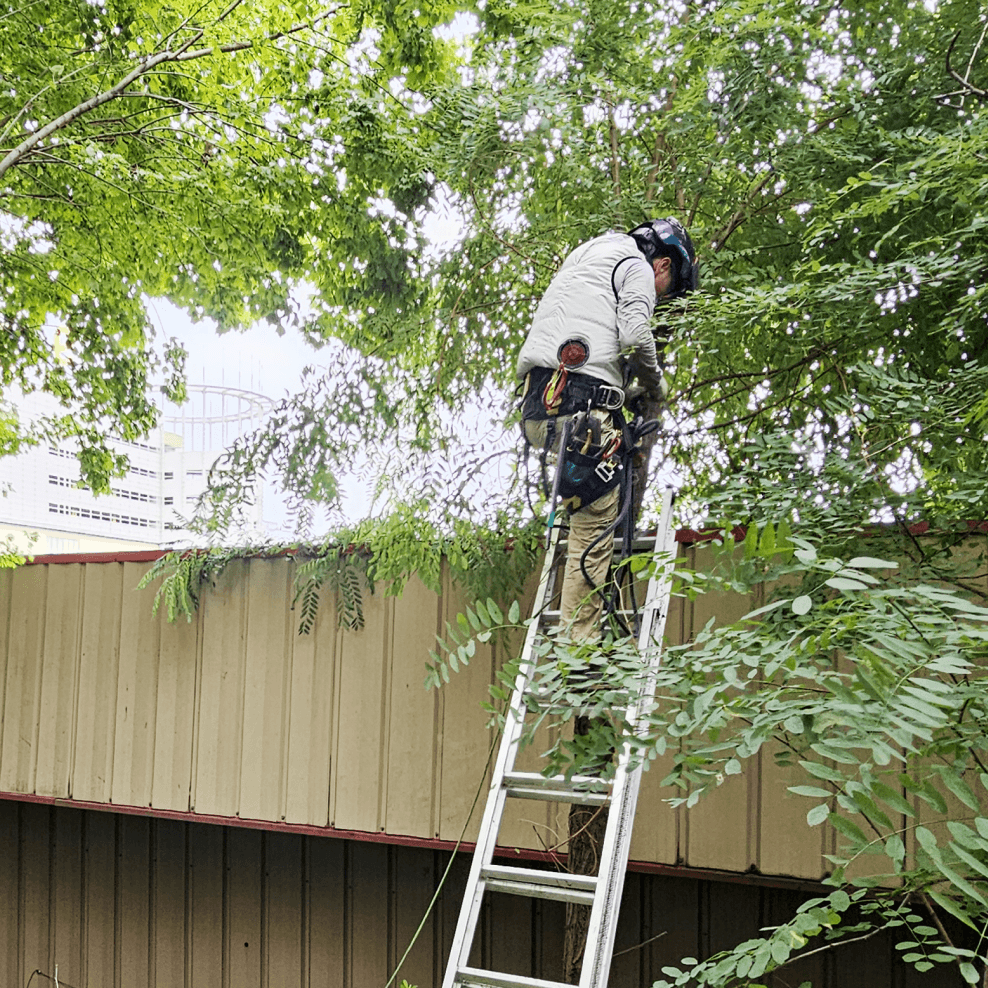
[0,548,876,878]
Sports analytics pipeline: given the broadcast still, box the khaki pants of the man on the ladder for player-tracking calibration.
[524,409,621,641]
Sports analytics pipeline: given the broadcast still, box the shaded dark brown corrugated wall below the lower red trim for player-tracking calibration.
[0,800,940,988]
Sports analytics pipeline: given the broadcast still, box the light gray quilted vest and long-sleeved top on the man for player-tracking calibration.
[517,233,661,395]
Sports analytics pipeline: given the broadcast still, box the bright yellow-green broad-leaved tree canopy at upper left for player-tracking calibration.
[0,0,462,490]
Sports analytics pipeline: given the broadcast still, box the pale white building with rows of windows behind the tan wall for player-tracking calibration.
[0,384,272,554]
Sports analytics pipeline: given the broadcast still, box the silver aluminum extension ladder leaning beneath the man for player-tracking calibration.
[443,491,676,988]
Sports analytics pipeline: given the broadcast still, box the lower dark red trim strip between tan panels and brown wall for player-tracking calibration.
[0,792,826,892]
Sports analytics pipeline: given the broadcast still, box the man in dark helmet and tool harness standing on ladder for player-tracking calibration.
[517,218,697,641]
